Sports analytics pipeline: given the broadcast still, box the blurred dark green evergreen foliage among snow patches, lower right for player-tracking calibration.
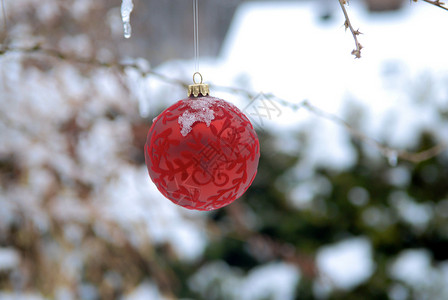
[166,127,448,299]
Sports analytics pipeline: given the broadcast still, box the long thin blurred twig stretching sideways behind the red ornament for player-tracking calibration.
[0,45,448,163]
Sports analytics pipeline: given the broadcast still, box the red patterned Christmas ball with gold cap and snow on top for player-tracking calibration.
[145,73,260,210]
